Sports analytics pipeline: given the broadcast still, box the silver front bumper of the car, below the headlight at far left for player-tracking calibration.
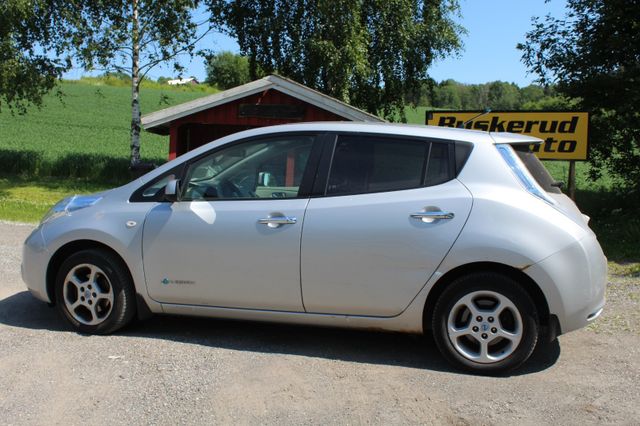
[20,225,51,303]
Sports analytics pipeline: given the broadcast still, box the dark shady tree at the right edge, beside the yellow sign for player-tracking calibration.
[518,0,640,190]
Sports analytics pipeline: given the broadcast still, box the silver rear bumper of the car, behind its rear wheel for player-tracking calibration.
[524,234,607,334]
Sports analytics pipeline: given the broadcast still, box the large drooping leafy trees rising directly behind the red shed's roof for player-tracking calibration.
[208,0,464,118]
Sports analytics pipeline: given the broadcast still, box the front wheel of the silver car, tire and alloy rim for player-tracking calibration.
[55,249,136,334]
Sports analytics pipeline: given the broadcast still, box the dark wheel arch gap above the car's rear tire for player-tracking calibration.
[422,262,557,331]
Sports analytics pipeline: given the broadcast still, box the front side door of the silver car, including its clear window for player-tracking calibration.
[143,134,319,311]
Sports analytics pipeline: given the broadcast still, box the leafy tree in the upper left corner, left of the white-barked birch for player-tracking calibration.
[0,0,82,113]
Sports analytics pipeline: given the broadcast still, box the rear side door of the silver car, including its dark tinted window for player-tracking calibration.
[301,134,472,316]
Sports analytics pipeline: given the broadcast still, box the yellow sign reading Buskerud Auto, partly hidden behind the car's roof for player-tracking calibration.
[426,111,589,160]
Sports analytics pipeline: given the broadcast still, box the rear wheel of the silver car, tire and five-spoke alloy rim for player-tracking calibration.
[432,272,540,374]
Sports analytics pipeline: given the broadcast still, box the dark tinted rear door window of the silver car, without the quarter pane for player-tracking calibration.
[326,135,429,195]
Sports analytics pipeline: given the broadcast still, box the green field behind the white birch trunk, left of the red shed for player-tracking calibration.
[0,78,215,182]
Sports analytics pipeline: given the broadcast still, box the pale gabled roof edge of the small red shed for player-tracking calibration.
[142,75,385,133]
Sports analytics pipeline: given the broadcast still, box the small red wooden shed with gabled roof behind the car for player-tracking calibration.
[142,75,384,159]
